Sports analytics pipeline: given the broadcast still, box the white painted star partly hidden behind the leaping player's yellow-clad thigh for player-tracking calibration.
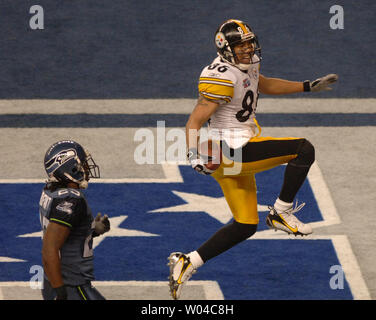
[149,191,269,224]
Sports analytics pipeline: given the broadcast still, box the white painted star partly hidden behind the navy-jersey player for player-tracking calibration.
[18,216,159,248]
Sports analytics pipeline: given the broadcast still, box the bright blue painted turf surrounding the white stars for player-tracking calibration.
[0,166,352,299]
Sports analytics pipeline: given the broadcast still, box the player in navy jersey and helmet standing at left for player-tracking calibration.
[39,140,110,300]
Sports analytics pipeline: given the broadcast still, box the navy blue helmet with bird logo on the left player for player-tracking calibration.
[44,140,100,189]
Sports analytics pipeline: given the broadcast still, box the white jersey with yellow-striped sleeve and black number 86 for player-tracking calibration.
[198,55,260,148]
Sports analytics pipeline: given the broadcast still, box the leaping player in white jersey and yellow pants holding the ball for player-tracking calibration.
[168,19,338,299]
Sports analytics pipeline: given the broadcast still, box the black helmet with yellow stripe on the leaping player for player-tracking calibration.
[214,19,261,70]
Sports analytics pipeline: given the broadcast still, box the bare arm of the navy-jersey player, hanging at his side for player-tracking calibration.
[42,222,70,288]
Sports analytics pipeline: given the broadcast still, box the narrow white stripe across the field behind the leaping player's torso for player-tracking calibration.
[0,97,376,114]
